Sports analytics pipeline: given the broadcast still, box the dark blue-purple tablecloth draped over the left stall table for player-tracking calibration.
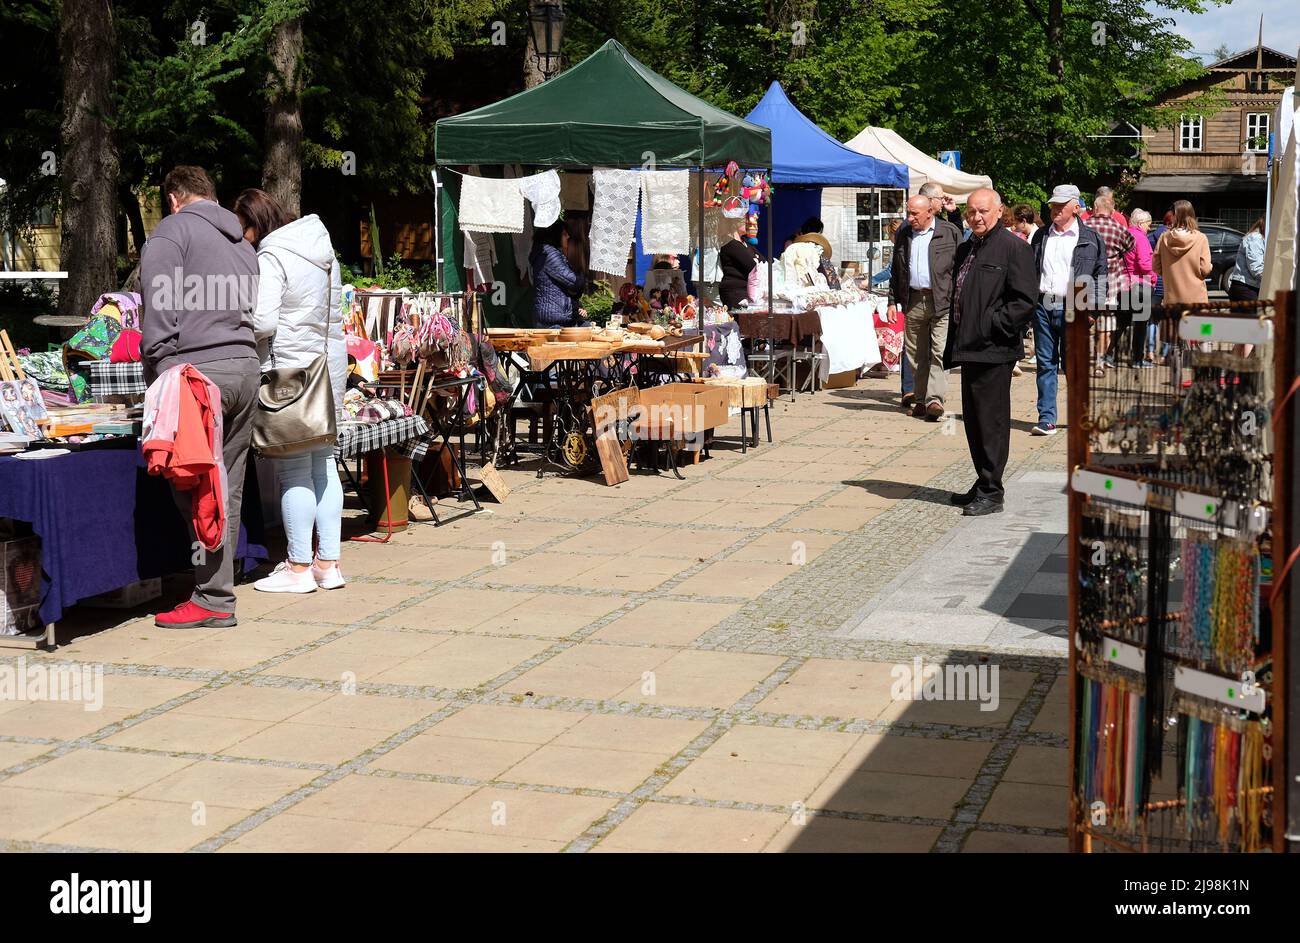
[0,449,267,624]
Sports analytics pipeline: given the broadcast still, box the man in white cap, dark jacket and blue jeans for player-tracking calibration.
[1031,185,1106,436]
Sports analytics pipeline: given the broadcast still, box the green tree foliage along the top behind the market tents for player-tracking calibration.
[0,0,1219,245]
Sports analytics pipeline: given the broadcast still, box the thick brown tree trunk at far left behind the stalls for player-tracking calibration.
[59,0,118,316]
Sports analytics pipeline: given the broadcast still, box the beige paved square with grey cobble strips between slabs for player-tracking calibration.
[0,372,1067,852]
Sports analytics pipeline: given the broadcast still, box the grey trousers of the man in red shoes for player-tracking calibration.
[172,358,261,613]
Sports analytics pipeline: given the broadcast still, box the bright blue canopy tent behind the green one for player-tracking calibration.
[745,82,907,267]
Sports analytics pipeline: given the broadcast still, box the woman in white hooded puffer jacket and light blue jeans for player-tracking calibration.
[234,190,347,593]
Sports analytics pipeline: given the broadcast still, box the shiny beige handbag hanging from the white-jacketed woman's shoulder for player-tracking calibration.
[252,302,338,458]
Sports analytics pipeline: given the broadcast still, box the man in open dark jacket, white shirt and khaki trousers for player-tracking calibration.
[889,195,962,423]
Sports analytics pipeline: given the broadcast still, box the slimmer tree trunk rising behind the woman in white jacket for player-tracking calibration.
[261,17,303,217]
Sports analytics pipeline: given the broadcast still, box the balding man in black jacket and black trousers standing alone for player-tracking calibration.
[944,189,1037,516]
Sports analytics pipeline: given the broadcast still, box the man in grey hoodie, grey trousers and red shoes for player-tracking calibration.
[140,166,260,628]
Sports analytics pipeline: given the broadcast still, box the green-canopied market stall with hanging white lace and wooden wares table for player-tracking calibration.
[436,40,771,470]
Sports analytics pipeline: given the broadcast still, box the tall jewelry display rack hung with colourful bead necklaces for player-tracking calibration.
[1066,293,1297,852]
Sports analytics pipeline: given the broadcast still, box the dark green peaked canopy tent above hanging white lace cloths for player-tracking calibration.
[434,39,772,307]
